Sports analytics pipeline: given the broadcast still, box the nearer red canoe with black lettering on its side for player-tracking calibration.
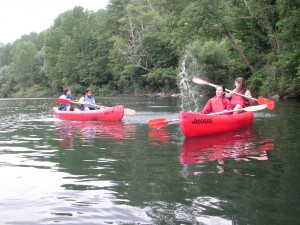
[179,112,254,137]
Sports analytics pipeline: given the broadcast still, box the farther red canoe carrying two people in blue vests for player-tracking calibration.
[52,105,124,121]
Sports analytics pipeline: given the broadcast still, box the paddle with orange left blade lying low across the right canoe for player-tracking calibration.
[148,104,267,129]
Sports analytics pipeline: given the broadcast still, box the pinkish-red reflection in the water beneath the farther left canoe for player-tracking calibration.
[54,120,136,148]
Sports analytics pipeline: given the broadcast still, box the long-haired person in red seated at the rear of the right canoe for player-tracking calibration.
[225,77,254,113]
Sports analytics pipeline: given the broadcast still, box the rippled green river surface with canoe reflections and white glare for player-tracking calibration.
[0,97,300,225]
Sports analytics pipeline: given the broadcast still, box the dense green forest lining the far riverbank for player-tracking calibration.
[0,0,300,98]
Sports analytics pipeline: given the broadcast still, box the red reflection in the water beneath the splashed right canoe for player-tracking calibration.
[179,128,274,174]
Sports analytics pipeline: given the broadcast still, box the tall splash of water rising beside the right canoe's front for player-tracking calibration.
[179,51,200,112]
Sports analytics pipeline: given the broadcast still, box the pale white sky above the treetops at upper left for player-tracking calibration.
[0,0,109,44]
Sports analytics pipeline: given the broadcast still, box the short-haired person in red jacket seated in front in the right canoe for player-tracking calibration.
[200,85,232,114]
